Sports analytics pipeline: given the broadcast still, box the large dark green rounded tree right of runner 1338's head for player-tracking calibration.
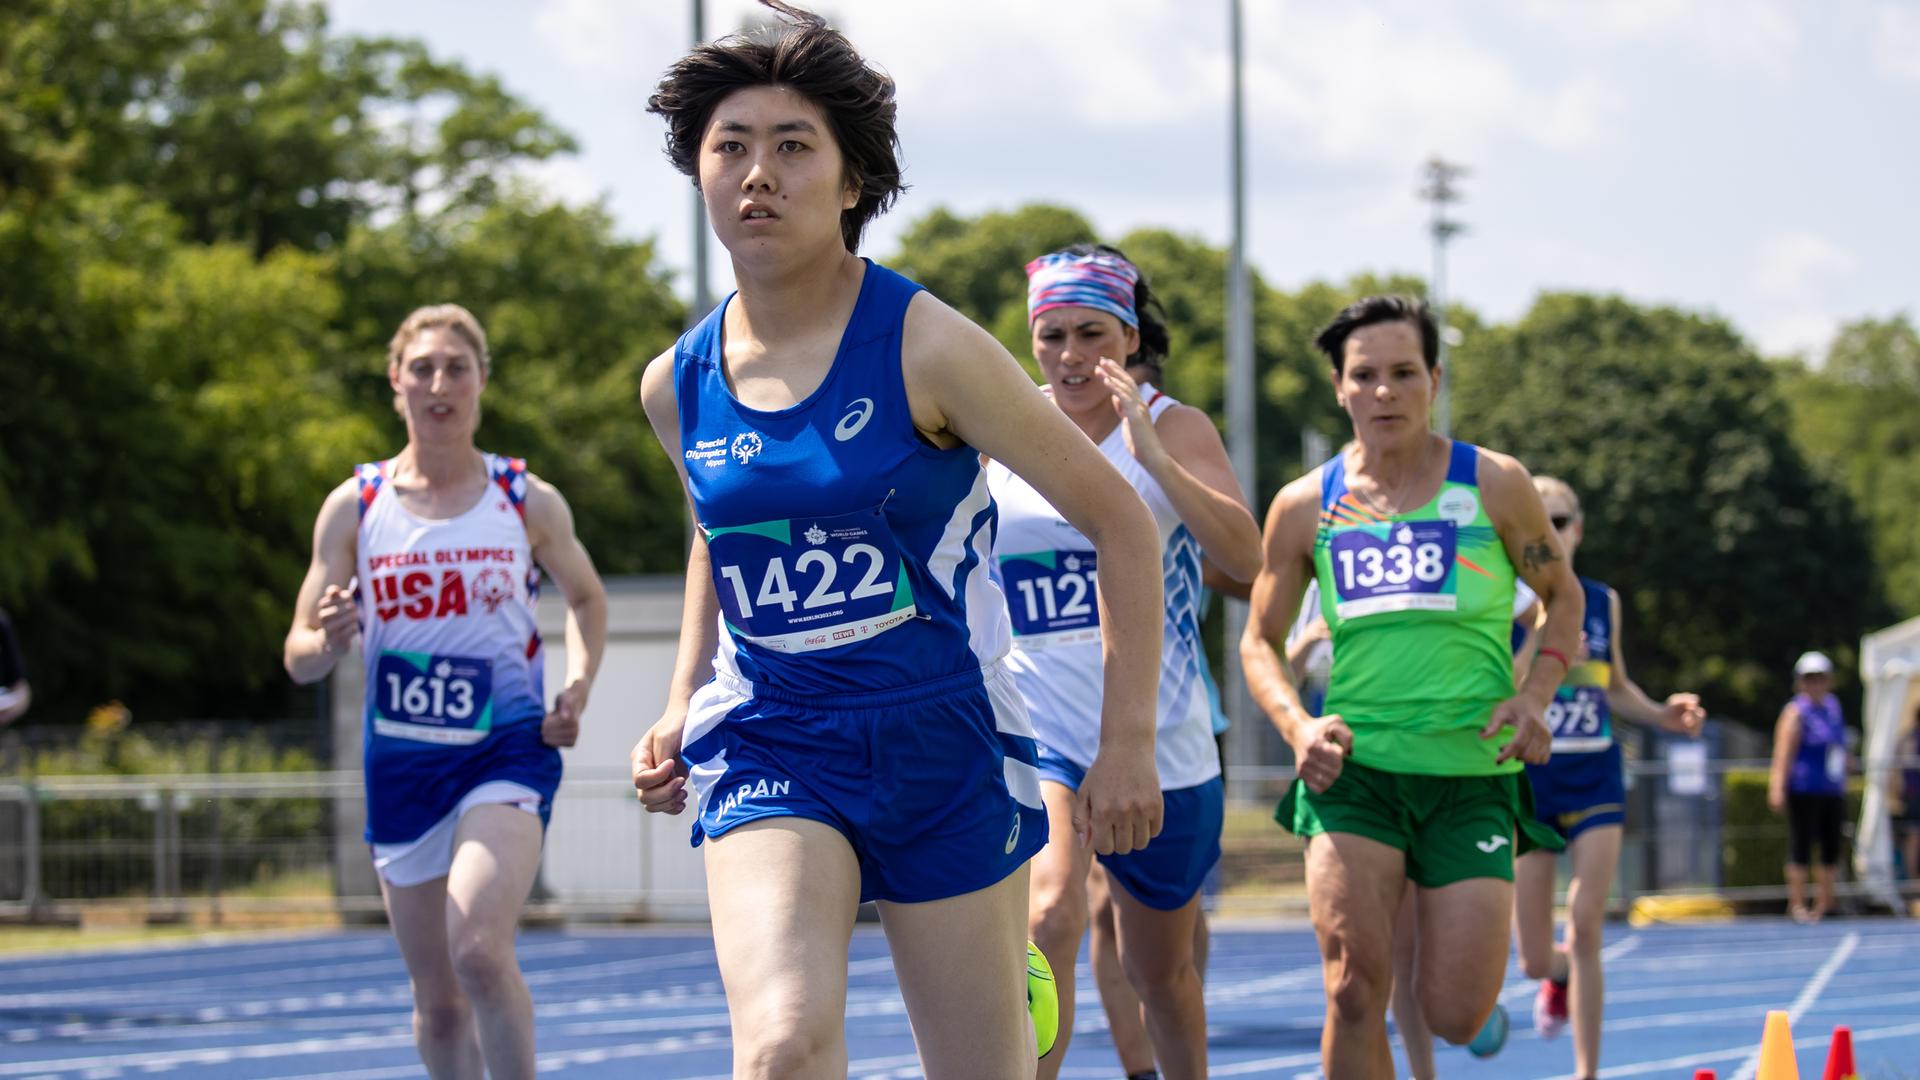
[1455,294,1878,723]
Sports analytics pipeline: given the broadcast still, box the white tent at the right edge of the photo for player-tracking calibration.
[1853,619,1920,911]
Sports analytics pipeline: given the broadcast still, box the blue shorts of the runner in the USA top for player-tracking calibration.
[365,717,561,846]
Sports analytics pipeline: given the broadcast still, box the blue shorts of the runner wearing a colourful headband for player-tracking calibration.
[1041,746,1227,911]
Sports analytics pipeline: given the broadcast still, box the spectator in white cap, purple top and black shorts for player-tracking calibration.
[1766,651,1847,922]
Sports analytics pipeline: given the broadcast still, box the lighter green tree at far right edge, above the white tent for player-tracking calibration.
[1784,315,1920,617]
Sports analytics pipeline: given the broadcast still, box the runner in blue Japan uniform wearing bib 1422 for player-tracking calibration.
[634,10,1162,1080]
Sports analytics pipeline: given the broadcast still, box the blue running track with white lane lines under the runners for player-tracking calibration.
[0,920,1920,1080]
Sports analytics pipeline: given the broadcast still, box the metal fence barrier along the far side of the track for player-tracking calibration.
[0,759,1920,924]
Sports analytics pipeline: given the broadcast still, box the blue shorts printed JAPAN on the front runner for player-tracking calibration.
[682,665,1046,903]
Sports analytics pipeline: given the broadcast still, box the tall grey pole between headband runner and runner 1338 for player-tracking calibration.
[1225,0,1263,791]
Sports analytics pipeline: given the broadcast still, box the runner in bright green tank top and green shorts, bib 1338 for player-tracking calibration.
[1240,296,1584,1080]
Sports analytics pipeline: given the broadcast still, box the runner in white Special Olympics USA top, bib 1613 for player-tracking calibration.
[284,304,607,1080]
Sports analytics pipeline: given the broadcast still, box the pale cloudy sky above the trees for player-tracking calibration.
[328,0,1920,354]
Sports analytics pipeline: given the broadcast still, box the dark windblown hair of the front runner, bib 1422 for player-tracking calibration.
[647,0,906,252]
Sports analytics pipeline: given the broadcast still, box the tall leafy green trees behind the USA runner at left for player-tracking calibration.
[0,0,682,721]
